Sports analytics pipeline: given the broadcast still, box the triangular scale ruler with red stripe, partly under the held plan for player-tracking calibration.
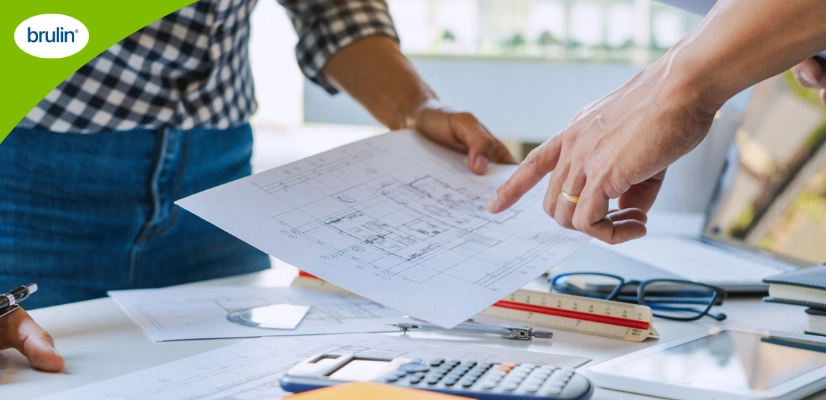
[292,271,659,342]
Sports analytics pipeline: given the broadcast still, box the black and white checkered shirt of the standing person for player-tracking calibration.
[18,0,398,133]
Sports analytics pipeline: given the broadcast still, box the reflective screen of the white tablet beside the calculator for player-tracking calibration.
[617,331,826,390]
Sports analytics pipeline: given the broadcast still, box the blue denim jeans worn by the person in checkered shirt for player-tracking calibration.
[0,125,270,309]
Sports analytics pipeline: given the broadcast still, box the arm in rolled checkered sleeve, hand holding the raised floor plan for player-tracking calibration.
[278,0,516,174]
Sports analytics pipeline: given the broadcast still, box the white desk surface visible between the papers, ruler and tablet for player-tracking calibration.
[0,264,826,400]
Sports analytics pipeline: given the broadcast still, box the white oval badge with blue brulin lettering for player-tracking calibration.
[14,14,89,58]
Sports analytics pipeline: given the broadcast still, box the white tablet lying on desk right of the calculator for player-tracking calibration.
[586,329,826,399]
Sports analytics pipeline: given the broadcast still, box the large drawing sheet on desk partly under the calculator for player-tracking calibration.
[41,334,590,400]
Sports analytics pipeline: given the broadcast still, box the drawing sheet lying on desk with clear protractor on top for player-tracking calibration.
[109,286,404,342]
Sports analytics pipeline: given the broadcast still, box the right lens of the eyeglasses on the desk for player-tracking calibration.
[642,281,715,319]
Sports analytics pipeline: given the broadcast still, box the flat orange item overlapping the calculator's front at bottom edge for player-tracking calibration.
[288,382,468,400]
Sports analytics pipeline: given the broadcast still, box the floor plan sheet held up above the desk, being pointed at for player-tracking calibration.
[177,131,588,327]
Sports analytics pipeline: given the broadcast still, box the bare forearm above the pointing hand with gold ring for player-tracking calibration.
[661,0,826,111]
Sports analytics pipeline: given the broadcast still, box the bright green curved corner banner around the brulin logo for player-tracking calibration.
[0,0,195,142]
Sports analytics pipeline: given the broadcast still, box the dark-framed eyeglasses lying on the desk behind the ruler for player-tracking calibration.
[548,272,726,321]
